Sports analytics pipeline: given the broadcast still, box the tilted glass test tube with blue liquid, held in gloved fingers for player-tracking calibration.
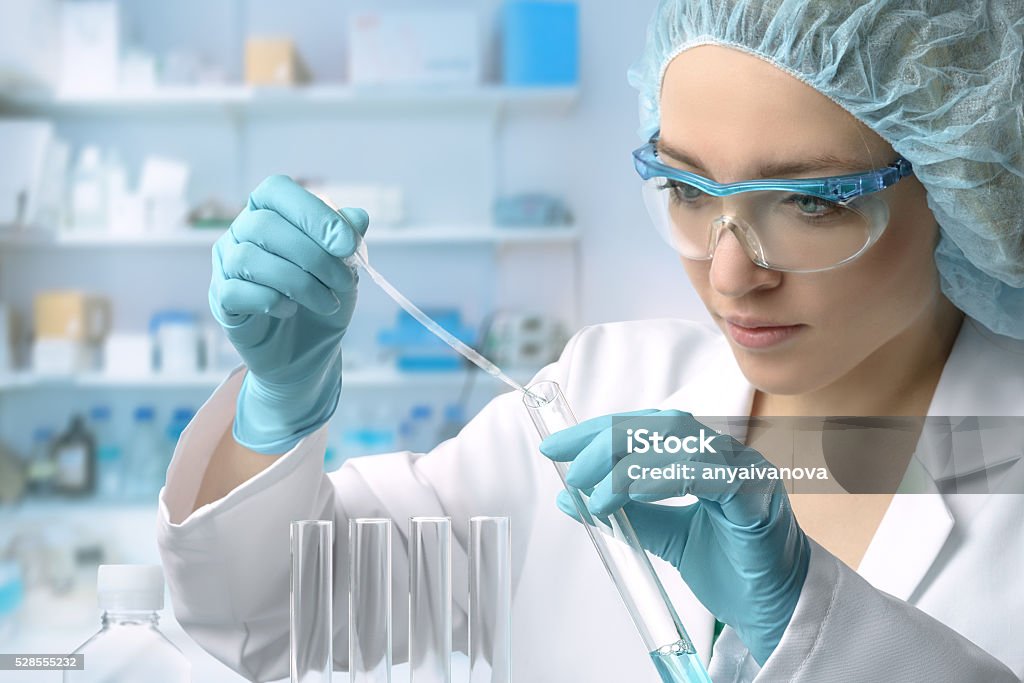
[523,381,712,683]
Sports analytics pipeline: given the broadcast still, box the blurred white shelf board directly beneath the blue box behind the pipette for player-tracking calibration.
[0,368,537,393]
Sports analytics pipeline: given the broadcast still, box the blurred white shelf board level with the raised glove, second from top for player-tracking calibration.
[0,225,580,249]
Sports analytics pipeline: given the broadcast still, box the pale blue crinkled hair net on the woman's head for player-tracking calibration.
[630,0,1024,338]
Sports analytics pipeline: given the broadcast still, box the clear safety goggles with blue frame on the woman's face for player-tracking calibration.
[633,135,913,272]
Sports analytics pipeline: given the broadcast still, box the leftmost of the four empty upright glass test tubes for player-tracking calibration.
[289,519,334,683]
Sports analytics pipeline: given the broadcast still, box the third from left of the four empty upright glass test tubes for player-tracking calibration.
[409,517,452,683]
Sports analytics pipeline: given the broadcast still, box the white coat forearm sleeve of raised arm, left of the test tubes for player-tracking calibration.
[157,370,334,681]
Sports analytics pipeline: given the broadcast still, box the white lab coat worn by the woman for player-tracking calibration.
[158,319,1024,683]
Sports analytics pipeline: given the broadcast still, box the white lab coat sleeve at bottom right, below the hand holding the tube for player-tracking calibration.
[710,541,1021,683]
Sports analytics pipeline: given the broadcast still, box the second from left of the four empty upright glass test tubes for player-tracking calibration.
[348,519,391,683]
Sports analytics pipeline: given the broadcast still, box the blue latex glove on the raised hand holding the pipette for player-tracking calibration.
[210,175,369,454]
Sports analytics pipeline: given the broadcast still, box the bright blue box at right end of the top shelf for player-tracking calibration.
[502,0,580,86]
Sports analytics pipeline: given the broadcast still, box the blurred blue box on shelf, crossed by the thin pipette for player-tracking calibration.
[377,308,474,372]
